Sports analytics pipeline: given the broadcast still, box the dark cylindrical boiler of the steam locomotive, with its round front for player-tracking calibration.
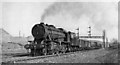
[32,23,65,41]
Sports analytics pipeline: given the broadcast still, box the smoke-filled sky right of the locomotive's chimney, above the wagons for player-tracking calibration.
[41,2,118,39]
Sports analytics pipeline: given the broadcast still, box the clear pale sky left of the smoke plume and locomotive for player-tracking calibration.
[3,2,53,36]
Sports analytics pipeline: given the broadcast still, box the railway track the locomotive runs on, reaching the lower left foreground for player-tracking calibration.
[2,49,101,64]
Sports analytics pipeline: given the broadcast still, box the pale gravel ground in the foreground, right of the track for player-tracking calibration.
[11,49,114,63]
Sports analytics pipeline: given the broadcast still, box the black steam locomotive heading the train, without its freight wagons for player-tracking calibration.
[24,23,102,56]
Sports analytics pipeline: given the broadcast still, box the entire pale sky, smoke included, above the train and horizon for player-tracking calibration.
[0,0,118,39]
